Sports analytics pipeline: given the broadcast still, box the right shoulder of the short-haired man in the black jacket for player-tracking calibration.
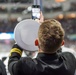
[62,52,76,71]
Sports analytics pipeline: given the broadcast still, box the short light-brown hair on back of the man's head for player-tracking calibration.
[38,19,65,53]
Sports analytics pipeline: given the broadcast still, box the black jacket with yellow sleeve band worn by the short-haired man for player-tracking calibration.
[8,44,76,75]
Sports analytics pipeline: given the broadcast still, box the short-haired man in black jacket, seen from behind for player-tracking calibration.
[8,19,76,75]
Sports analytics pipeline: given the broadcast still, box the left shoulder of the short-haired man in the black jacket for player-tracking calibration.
[14,57,36,75]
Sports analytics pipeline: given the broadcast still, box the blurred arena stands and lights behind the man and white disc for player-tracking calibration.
[0,0,76,58]
